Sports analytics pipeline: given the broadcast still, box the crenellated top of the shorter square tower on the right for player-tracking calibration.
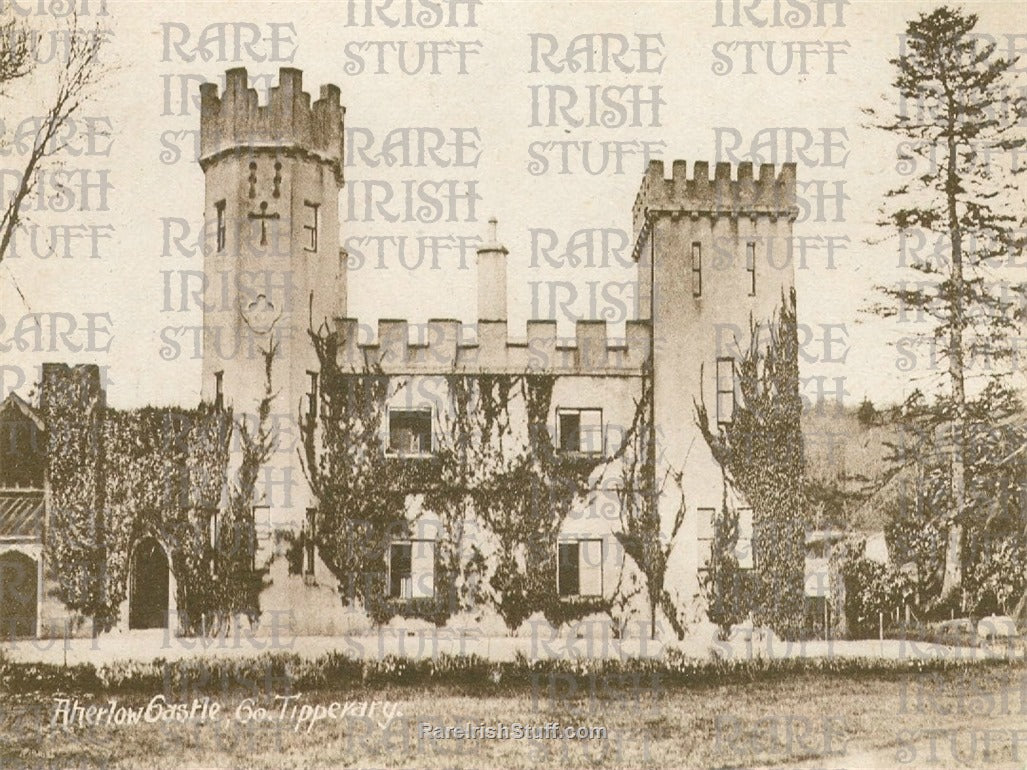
[632,160,798,242]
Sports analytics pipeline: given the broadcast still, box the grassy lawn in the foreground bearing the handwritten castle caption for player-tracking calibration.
[6,664,1027,770]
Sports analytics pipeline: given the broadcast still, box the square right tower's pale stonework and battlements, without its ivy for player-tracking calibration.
[633,160,798,612]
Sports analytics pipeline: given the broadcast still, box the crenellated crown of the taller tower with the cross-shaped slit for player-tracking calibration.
[199,67,346,184]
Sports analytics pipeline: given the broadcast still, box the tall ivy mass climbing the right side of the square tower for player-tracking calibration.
[695,290,806,639]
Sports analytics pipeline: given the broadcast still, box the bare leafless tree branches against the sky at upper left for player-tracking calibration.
[0,9,107,262]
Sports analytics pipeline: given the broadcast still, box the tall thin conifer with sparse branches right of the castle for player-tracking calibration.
[867,7,1027,600]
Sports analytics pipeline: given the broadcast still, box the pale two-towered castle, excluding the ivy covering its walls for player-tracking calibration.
[0,69,797,633]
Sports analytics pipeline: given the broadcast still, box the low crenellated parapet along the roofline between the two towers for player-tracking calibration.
[335,318,650,377]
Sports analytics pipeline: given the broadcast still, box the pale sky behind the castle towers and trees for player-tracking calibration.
[0,0,1027,407]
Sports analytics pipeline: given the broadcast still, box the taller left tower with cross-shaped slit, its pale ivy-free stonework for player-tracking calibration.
[199,68,345,528]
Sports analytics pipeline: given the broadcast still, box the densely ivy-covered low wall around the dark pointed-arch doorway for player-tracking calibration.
[40,364,261,632]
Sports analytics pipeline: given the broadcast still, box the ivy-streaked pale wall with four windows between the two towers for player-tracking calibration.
[294,334,662,631]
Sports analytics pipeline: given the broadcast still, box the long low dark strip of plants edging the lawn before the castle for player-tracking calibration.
[0,649,1013,697]
